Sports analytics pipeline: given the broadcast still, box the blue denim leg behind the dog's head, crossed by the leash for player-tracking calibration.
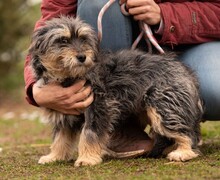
[77,0,132,51]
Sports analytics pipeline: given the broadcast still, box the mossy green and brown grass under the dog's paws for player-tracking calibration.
[0,116,220,180]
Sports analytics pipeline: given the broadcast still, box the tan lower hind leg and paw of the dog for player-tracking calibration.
[147,108,199,161]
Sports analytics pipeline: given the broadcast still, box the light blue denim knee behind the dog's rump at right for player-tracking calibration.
[180,42,220,120]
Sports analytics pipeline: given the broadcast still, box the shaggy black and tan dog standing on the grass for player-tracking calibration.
[29,16,204,166]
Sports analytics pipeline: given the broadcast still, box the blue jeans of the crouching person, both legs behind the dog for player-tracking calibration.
[77,0,220,120]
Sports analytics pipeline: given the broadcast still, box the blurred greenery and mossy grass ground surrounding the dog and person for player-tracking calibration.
[0,0,220,180]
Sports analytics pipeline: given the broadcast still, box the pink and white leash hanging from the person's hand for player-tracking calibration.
[97,0,165,54]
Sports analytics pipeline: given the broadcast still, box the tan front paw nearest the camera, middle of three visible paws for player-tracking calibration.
[74,157,102,167]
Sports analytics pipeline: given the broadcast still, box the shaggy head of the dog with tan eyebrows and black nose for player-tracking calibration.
[29,16,98,79]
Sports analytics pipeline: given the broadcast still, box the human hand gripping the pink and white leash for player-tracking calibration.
[119,0,161,25]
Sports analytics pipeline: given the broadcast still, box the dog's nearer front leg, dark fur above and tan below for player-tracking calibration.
[75,105,111,167]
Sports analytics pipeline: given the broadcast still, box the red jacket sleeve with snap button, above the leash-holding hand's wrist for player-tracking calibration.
[158,0,220,45]
